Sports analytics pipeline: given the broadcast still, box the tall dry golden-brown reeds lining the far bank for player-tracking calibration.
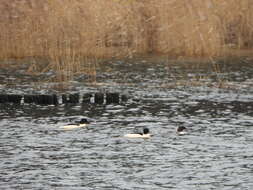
[0,0,253,80]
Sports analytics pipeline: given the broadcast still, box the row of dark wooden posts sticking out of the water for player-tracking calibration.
[0,93,127,105]
